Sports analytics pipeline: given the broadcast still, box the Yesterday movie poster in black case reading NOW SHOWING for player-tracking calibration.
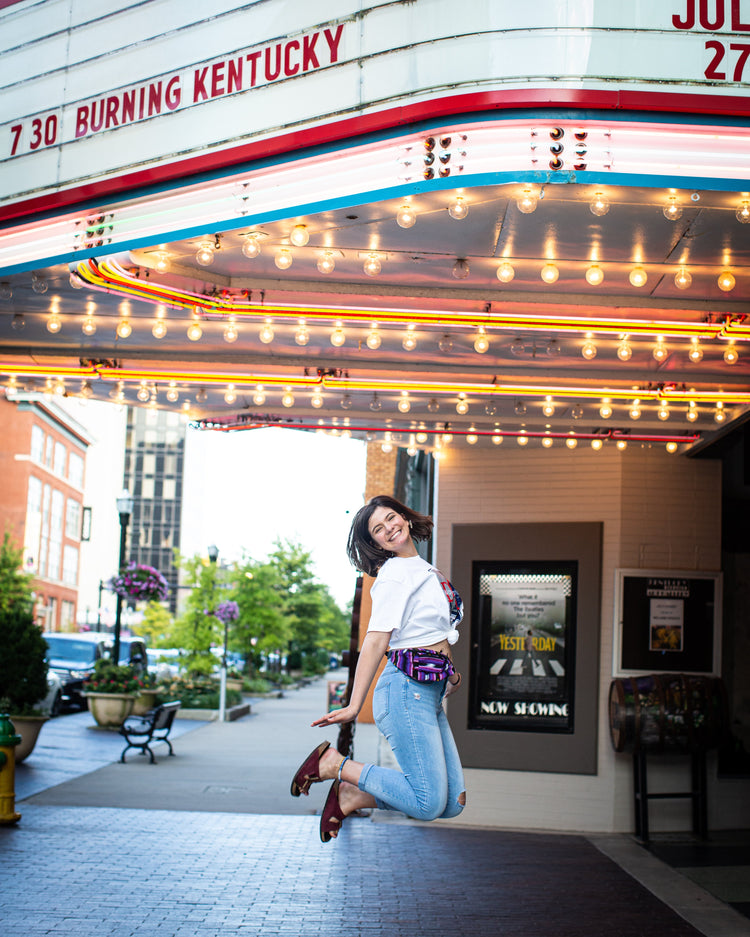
[470,562,577,732]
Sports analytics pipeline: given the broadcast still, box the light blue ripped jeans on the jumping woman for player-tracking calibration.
[359,661,465,820]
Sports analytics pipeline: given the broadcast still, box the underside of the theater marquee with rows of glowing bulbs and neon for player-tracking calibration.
[0,120,750,451]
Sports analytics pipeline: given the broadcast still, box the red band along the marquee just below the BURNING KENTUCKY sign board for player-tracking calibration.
[0,88,750,221]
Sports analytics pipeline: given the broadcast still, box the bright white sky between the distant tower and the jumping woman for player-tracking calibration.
[181,427,366,608]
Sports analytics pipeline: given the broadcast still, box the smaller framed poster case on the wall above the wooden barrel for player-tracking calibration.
[613,569,722,677]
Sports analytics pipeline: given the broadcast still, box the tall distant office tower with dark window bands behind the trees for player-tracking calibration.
[123,407,185,613]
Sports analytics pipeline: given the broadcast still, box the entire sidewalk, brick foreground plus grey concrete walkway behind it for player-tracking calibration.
[0,668,750,937]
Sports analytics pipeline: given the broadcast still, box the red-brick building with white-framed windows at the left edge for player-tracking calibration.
[0,393,92,631]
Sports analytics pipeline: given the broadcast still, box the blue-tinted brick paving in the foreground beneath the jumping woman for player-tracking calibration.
[0,804,699,937]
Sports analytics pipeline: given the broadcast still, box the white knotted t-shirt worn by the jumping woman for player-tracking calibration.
[367,556,458,649]
